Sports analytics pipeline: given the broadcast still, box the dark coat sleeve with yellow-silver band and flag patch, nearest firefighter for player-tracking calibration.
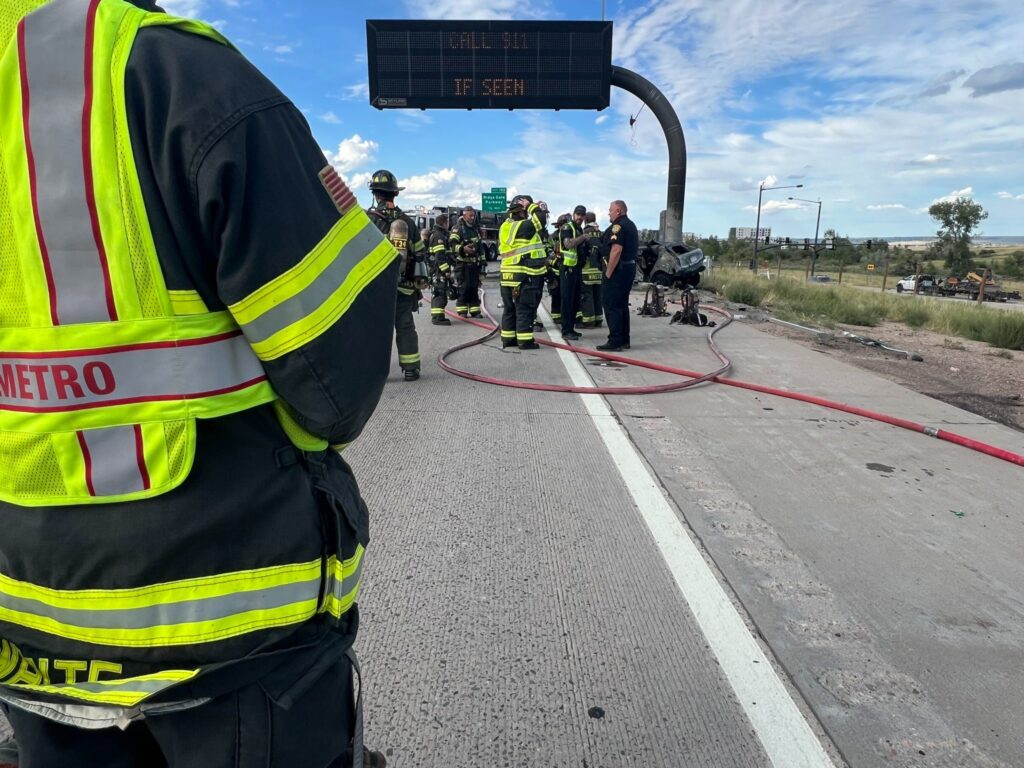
[126,28,397,443]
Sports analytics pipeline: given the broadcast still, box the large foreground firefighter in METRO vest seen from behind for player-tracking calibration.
[0,0,397,768]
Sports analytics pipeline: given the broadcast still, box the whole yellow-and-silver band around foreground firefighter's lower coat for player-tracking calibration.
[0,558,331,648]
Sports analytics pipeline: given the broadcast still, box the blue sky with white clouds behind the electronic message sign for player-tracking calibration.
[162,0,1024,237]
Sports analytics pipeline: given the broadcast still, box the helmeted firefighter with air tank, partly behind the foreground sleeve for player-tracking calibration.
[367,170,427,381]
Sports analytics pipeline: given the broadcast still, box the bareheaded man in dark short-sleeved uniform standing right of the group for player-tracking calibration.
[597,200,640,352]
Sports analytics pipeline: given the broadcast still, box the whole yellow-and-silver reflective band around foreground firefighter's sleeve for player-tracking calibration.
[228,208,398,360]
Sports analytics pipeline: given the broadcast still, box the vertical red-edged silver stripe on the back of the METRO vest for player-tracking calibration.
[23,0,114,324]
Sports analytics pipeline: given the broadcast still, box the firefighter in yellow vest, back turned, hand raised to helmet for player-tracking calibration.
[498,195,548,349]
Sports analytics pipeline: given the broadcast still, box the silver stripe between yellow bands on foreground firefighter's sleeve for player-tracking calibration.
[242,222,384,344]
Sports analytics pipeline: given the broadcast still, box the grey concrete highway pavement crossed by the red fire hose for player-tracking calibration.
[348,289,1024,768]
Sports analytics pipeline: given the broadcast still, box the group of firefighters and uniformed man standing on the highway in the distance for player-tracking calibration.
[369,170,637,381]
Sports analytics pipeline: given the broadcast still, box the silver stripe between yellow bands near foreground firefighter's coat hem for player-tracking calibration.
[0,577,317,634]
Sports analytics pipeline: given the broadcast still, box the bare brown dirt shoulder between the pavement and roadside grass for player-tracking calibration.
[742,312,1024,432]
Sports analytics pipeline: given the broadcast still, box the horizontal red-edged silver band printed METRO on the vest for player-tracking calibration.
[0,331,266,413]
